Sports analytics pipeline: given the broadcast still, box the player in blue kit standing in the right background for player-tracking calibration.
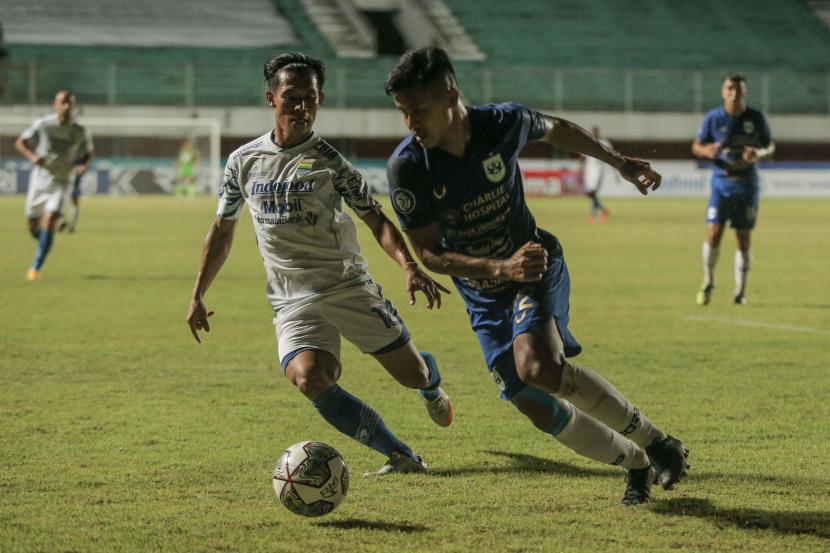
[692,74,775,305]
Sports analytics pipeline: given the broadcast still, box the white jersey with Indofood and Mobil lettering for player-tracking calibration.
[217,133,380,309]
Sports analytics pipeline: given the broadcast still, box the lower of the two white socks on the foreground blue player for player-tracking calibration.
[554,406,649,470]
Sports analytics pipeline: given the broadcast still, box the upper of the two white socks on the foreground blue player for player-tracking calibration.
[556,362,666,447]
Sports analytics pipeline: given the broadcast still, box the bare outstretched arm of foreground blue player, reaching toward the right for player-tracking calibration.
[541,115,662,195]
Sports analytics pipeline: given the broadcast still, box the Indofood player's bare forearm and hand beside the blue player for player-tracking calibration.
[360,209,450,309]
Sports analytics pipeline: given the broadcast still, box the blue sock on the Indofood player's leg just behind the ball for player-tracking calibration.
[311,384,417,459]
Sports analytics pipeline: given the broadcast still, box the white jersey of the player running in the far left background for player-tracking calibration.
[21,113,92,190]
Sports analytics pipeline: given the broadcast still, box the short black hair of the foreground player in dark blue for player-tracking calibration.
[384,46,458,96]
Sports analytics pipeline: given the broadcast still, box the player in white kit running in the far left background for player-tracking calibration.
[14,90,92,282]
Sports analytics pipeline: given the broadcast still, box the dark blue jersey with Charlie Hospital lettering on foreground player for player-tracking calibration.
[387,103,555,303]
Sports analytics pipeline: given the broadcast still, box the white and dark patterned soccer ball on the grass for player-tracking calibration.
[274,441,349,517]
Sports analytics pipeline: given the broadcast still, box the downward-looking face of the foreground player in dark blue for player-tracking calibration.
[394,84,458,148]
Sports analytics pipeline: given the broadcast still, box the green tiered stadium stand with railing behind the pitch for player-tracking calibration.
[0,0,830,114]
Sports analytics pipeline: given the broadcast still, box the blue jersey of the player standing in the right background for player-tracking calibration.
[697,106,772,186]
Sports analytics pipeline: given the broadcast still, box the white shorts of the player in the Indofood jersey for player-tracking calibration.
[274,281,409,369]
